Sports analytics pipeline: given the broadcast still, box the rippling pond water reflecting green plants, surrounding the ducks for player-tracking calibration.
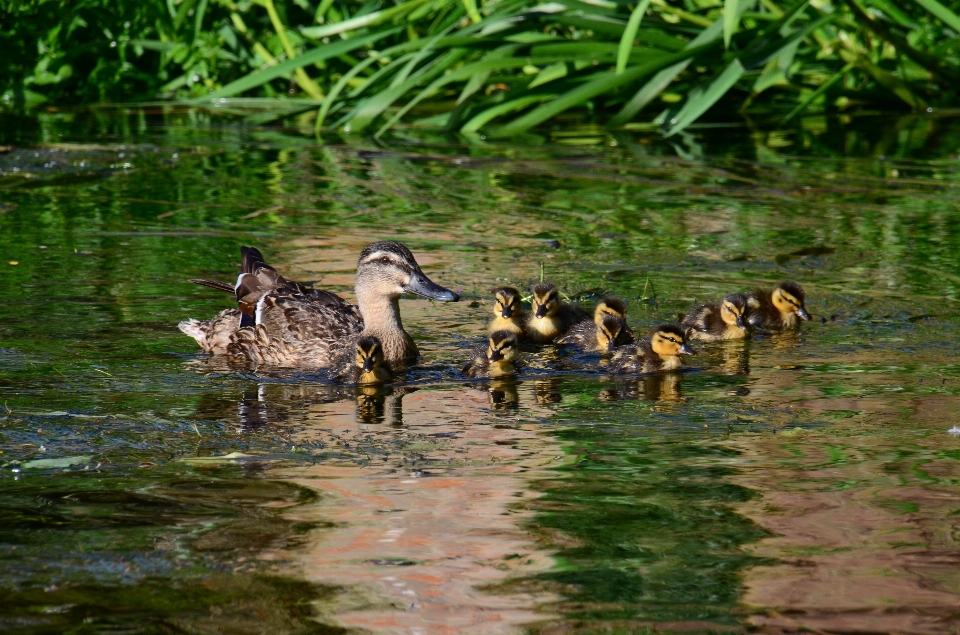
[0,110,960,635]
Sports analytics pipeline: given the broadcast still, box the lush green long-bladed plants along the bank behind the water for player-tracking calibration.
[0,0,960,138]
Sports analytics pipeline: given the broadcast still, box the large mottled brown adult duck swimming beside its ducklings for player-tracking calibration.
[179,241,460,368]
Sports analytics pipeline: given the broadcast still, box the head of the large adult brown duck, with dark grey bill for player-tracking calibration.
[356,240,460,302]
